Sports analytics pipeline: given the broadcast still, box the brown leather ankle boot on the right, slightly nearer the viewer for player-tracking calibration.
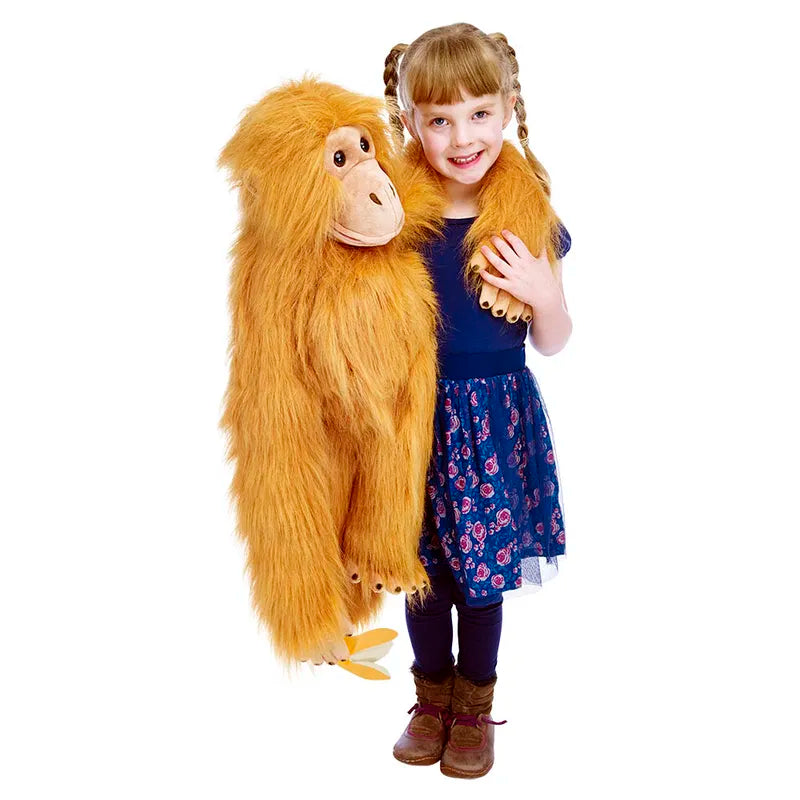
[439,667,508,778]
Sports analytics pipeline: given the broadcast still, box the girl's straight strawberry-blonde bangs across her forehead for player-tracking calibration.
[401,38,504,108]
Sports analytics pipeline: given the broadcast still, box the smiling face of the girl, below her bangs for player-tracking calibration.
[401,90,517,188]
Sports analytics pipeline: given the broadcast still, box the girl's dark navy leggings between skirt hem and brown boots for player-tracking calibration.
[406,570,503,681]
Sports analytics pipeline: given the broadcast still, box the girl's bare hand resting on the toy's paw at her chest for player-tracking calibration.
[480,230,561,311]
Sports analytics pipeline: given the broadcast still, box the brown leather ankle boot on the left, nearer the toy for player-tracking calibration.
[393,664,455,766]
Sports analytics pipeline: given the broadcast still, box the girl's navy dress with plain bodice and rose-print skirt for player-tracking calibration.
[419,217,571,606]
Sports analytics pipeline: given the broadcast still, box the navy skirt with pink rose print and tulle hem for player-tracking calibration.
[419,367,566,606]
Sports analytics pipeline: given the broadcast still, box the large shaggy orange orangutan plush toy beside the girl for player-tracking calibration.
[219,78,444,665]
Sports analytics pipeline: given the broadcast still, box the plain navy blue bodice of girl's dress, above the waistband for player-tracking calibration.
[422,217,571,356]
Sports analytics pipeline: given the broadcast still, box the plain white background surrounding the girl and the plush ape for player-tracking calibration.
[0,0,800,798]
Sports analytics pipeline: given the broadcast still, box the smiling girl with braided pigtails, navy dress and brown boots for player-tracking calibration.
[384,24,572,778]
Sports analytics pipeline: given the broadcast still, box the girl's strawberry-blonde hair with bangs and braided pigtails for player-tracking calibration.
[383,22,550,197]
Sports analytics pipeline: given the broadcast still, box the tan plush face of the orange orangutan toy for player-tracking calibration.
[324,125,405,247]
